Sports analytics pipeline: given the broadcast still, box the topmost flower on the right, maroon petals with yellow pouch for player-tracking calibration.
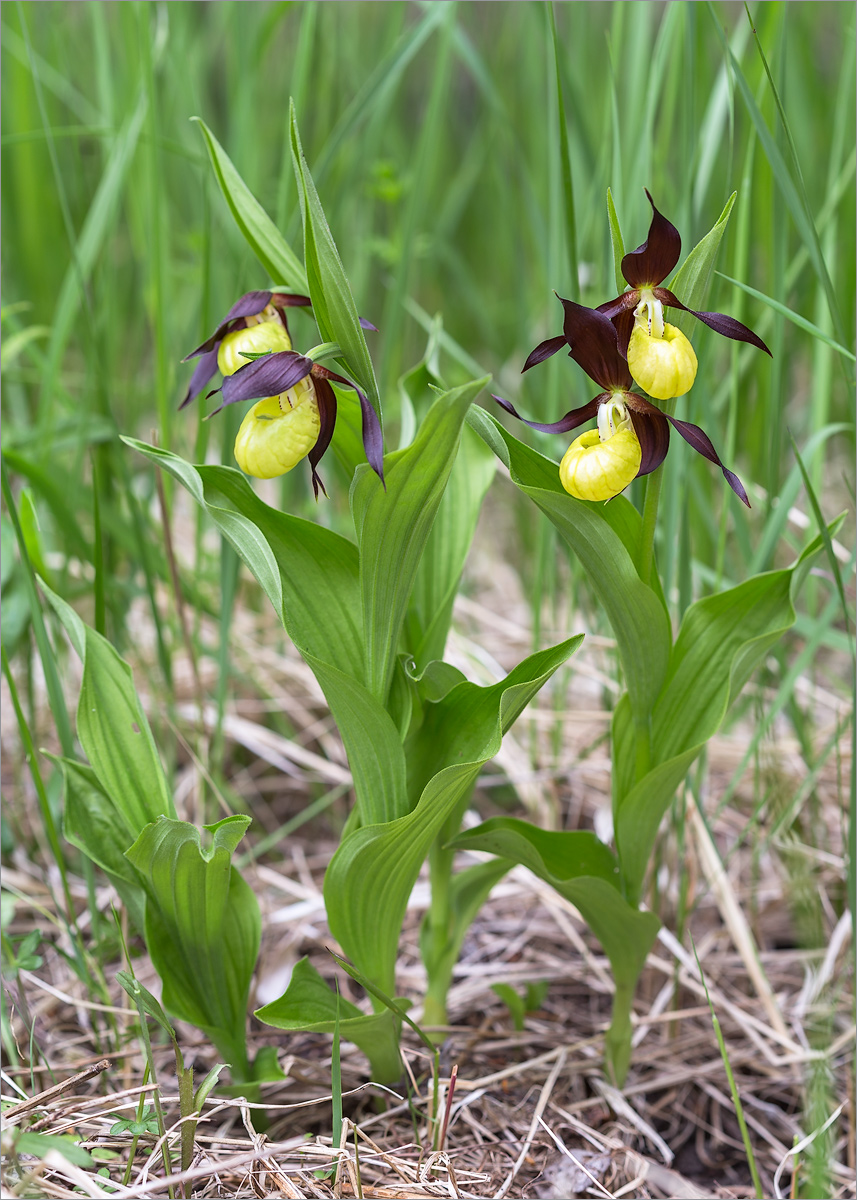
[525,190,771,400]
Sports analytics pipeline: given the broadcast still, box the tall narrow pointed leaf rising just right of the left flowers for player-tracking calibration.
[289,101,382,420]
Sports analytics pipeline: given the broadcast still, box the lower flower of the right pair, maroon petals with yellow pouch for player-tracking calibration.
[493,304,750,508]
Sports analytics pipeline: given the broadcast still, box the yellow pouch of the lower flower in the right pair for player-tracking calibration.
[559,396,642,500]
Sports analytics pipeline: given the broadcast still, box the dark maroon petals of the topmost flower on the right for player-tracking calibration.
[523,188,771,371]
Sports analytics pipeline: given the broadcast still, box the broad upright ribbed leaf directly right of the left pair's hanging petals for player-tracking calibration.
[352,379,486,703]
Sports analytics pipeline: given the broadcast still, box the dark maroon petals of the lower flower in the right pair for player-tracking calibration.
[493,304,750,509]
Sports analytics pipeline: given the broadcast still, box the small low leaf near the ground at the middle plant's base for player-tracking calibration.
[256,958,407,1082]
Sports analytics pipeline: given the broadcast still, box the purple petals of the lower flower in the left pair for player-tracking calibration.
[210,350,384,499]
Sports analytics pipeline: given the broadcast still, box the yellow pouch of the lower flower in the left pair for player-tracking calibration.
[234,376,322,479]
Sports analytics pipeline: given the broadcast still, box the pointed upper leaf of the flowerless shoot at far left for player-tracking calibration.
[42,583,175,830]
